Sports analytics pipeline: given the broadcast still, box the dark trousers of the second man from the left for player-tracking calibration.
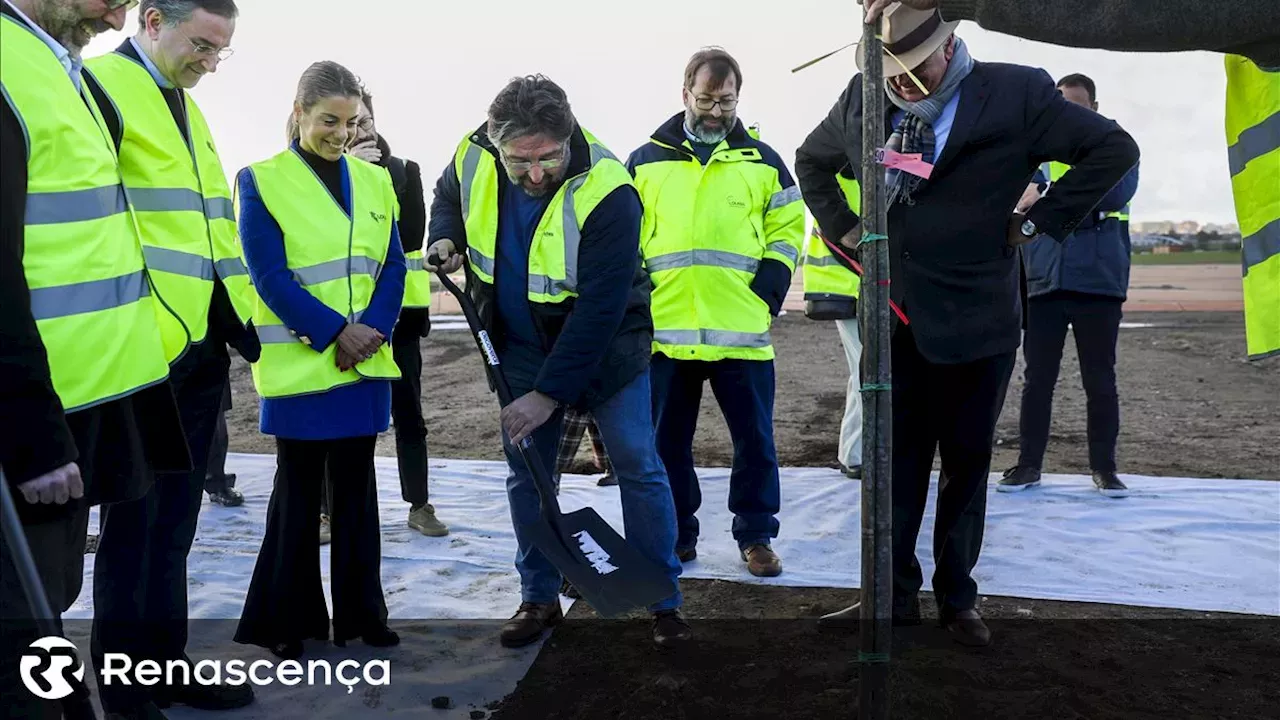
[91,342,230,712]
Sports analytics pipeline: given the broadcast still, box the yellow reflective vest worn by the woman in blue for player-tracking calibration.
[241,149,399,397]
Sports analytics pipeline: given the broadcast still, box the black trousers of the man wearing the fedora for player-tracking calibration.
[892,325,1014,609]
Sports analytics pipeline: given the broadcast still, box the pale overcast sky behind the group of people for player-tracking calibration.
[86,0,1234,223]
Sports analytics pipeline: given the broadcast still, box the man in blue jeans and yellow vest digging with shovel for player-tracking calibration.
[426,76,690,647]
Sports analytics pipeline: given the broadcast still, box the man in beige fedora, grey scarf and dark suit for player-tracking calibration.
[796,4,1138,646]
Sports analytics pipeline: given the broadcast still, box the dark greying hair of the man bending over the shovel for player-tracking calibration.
[486,74,576,149]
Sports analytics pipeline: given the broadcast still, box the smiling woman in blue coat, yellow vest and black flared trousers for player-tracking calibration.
[236,61,406,659]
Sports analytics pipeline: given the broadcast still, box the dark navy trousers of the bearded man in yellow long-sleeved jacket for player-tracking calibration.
[652,355,782,550]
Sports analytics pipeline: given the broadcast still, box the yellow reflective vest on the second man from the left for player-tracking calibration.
[87,53,252,363]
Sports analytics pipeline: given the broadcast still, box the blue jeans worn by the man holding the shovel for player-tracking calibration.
[502,372,684,612]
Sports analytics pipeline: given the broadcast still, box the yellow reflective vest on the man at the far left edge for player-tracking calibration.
[0,15,169,409]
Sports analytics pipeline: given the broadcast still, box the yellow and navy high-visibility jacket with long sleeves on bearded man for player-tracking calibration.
[627,114,804,361]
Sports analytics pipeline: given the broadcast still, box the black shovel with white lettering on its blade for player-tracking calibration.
[428,254,676,618]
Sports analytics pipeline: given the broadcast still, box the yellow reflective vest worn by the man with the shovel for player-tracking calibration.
[454,131,631,304]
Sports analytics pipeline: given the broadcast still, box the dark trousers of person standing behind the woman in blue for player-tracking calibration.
[320,333,429,515]
